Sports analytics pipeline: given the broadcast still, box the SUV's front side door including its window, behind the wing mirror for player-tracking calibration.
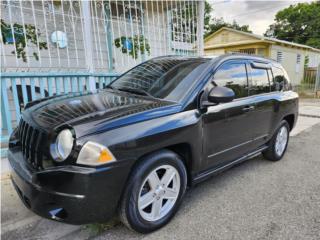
[203,61,255,168]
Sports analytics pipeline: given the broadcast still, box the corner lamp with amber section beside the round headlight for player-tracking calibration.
[77,142,116,166]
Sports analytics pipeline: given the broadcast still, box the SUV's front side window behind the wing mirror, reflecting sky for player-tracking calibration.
[213,63,248,98]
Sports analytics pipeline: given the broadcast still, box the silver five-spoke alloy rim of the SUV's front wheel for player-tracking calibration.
[138,165,180,221]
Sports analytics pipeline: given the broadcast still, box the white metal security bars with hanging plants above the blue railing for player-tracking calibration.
[0,0,203,72]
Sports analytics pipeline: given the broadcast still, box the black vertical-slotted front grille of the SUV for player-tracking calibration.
[19,119,46,170]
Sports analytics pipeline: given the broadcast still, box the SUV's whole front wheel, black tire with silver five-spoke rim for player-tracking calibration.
[120,150,187,233]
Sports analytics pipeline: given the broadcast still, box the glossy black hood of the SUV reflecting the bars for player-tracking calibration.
[22,90,178,137]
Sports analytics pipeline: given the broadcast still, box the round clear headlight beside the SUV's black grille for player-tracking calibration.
[51,129,74,162]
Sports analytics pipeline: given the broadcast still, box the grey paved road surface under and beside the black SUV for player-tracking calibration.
[1,124,320,240]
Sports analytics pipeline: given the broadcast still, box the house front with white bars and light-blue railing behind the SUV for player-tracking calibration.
[0,0,204,150]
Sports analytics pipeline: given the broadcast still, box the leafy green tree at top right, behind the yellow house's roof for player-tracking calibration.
[265,1,320,48]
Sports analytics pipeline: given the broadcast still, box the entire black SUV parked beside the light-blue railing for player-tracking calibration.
[8,55,298,233]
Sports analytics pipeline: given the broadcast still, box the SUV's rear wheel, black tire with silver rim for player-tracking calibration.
[262,120,290,161]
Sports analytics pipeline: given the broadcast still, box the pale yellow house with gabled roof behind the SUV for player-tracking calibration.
[204,27,320,85]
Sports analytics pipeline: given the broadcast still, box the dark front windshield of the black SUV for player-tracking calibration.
[109,57,208,101]
